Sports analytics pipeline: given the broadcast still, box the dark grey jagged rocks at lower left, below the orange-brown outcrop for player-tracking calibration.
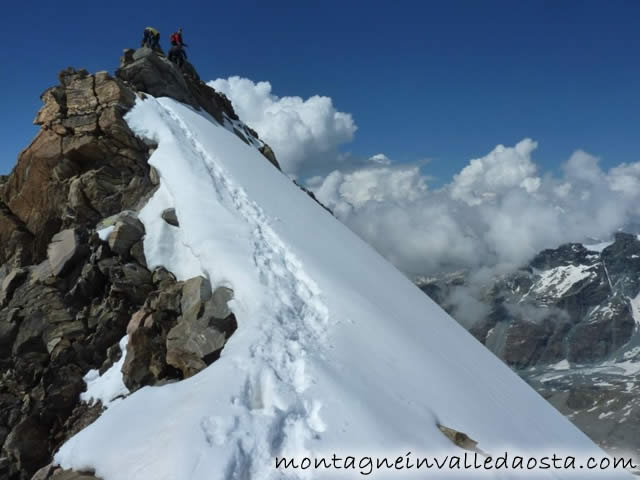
[0,227,153,479]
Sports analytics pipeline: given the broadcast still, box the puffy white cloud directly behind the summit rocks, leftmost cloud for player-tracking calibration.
[209,76,357,176]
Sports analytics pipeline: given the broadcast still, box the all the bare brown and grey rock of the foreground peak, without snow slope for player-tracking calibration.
[0,49,279,480]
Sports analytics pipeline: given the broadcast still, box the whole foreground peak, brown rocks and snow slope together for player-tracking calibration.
[0,49,627,480]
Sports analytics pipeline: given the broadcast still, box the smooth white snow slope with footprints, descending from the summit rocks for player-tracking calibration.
[56,97,626,480]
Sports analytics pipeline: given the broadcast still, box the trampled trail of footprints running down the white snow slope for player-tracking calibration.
[154,103,329,478]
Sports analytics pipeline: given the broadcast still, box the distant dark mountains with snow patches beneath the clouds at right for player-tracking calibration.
[418,233,640,462]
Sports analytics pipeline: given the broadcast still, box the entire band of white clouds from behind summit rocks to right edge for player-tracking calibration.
[209,77,640,282]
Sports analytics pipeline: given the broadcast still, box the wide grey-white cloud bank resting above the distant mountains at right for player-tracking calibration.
[309,139,640,276]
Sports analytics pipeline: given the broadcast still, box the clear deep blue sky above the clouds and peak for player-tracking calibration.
[0,0,640,181]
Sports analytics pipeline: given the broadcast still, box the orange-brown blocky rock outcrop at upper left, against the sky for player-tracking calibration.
[0,68,153,266]
